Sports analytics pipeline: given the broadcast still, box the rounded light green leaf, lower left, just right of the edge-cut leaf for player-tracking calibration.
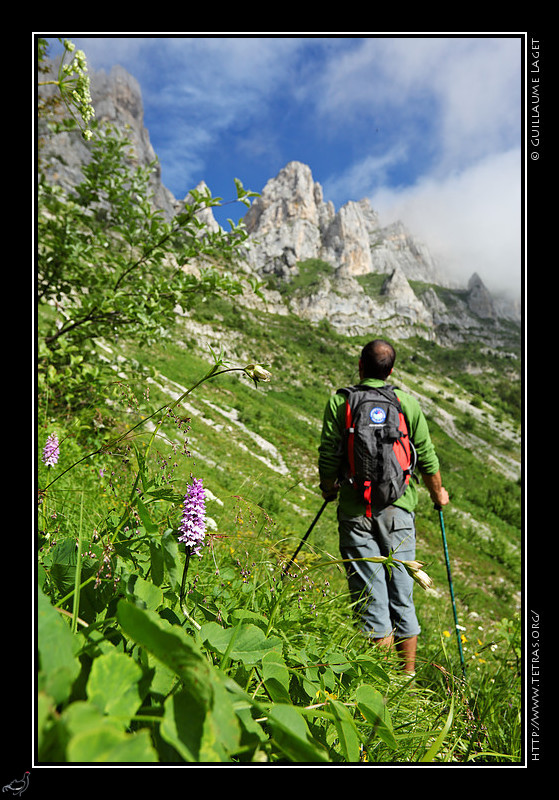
[87,653,142,723]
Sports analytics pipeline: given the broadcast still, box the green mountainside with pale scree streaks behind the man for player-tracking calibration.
[109,286,521,668]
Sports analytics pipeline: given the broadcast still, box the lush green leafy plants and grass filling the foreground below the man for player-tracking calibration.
[37,354,520,765]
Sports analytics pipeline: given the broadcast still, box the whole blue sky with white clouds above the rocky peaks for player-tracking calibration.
[42,32,524,297]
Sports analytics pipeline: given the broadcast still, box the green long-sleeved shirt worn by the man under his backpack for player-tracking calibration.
[318,378,439,516]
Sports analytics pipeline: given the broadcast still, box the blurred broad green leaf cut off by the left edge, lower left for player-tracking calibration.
[37,590,81,704]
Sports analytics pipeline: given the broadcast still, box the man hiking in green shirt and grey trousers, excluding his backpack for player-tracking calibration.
[318,339,449,674]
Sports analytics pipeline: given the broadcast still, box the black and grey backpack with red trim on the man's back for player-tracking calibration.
[337,386,417,517]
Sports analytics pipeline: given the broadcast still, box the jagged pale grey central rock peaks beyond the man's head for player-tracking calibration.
[241,161,520,342]
